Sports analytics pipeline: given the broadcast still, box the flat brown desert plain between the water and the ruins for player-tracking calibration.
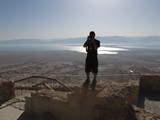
[0,49,160,83]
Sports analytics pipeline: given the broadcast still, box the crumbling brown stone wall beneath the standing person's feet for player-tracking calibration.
[25,82,138,120]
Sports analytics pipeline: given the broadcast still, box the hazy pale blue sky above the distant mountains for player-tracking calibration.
[0,0,160,40]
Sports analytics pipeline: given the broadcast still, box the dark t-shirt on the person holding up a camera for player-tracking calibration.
[85,39,100,56]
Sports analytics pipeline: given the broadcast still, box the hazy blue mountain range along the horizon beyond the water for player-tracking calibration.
[0,36,160,46]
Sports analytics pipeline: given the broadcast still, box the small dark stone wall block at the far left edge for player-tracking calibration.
[0,81,15,105]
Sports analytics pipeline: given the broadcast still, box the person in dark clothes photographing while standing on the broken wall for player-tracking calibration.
[83,31,100,89]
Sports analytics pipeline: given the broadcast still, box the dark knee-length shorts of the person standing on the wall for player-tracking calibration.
[85,56,98,73]
